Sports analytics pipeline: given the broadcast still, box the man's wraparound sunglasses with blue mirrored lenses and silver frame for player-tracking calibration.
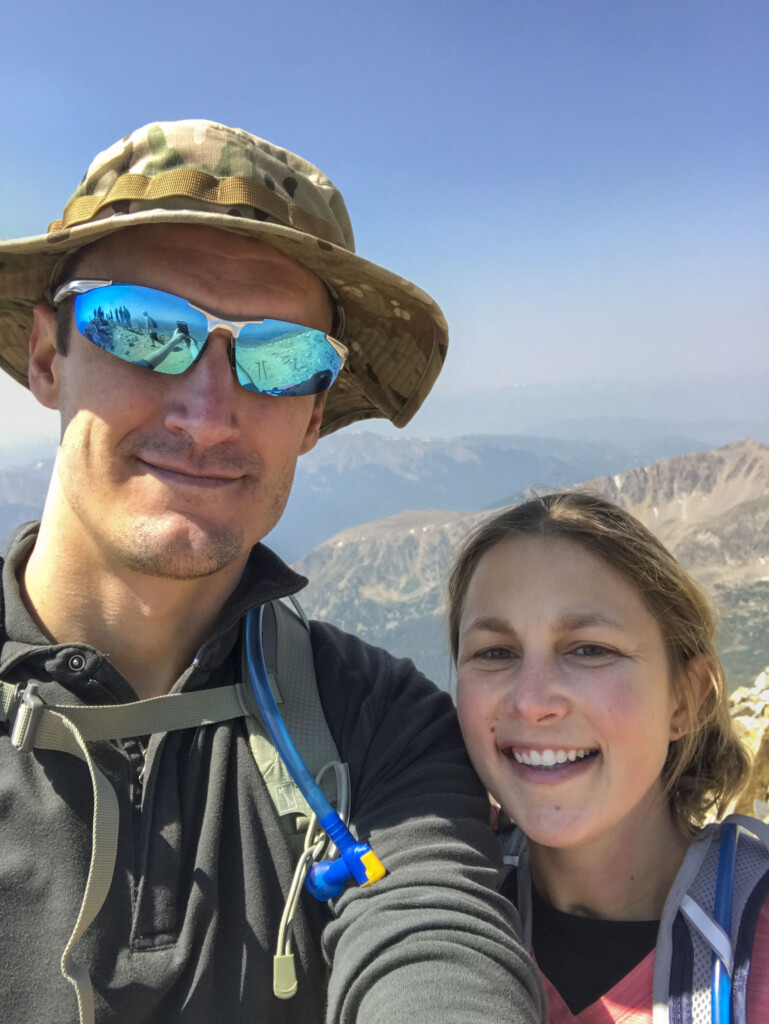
[53,281,347,395]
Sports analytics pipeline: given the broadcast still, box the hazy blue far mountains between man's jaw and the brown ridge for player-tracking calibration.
[268,431,709,560]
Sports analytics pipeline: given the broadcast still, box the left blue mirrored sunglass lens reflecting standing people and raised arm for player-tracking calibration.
[75,285,208,374]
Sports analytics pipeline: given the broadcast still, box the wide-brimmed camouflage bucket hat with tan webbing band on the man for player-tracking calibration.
[0,121,448,433]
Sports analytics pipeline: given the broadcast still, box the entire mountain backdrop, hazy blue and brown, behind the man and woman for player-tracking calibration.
[0,431,769,688]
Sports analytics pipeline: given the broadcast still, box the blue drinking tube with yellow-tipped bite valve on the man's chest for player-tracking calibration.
[246,607,385,900]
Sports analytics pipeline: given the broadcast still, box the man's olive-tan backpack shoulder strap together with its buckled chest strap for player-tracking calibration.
[0,602,339,1024]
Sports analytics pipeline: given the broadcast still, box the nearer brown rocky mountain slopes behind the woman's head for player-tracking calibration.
[295,440,769,689]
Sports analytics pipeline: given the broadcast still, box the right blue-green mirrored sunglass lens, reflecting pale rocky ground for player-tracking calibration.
[234,319,342,395]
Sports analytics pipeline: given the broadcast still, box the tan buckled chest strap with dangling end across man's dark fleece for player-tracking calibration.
[0,681,249,1024]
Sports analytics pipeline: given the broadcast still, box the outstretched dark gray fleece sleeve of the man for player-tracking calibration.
[312,623,547,1024]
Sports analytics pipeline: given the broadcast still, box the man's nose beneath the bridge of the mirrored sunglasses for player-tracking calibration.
[166,329,242,445]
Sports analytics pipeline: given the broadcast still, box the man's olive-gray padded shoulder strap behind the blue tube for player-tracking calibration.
[243,601,340,855]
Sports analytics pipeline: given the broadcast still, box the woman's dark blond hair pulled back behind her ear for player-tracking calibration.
[448,490,750,835]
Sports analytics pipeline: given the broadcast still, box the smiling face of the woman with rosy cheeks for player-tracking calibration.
[457,537,684,848]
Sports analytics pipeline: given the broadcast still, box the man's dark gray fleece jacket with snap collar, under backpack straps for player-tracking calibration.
[0,526,545,1024]
